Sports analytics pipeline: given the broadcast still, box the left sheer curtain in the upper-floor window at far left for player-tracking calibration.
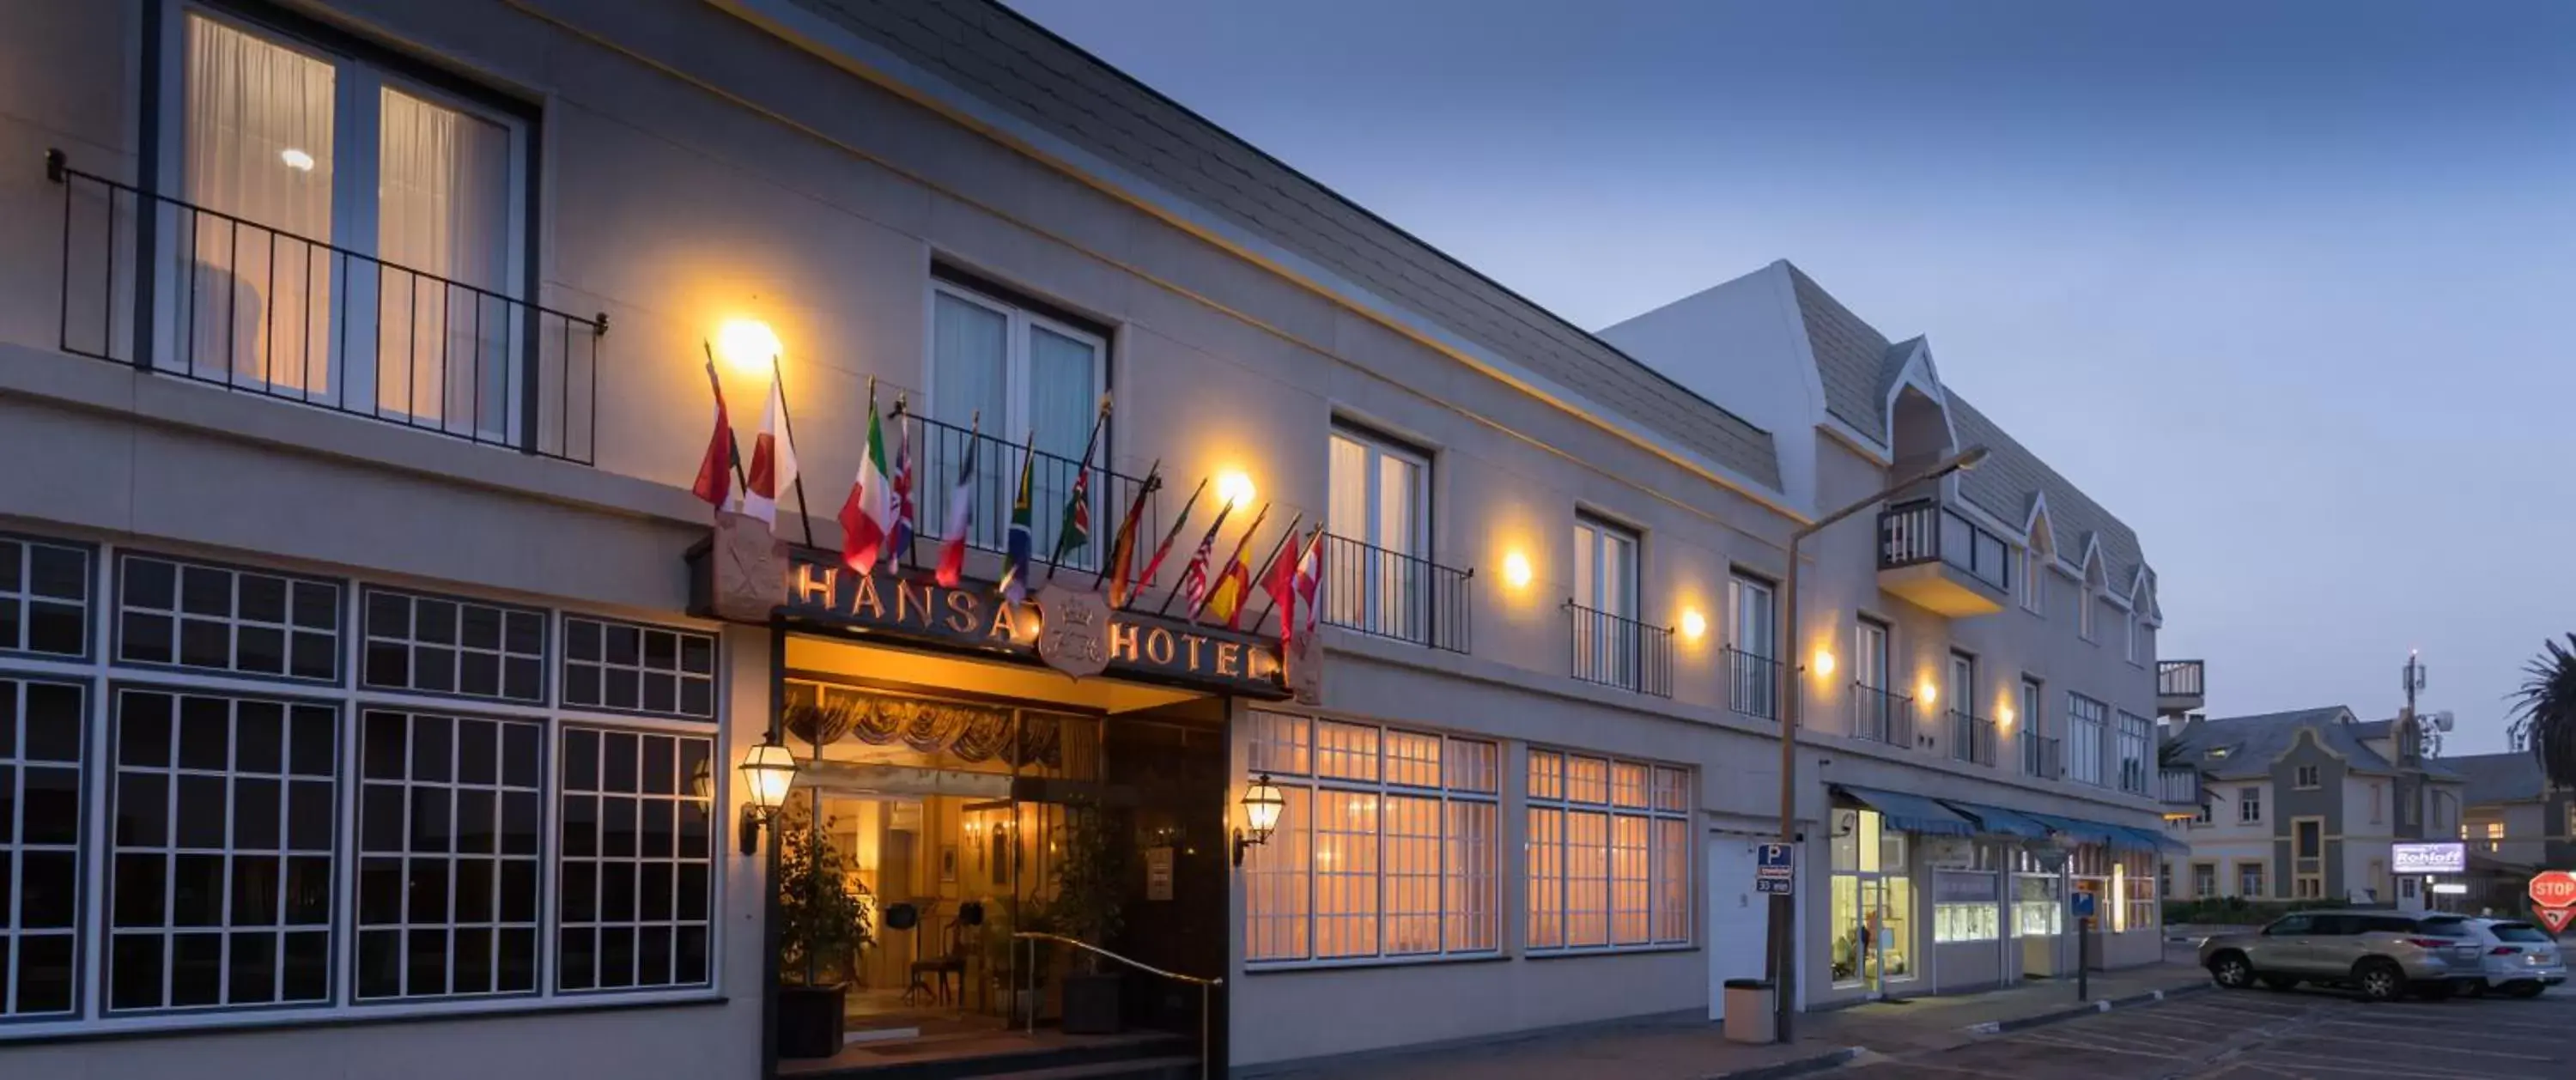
[170,15,337,397]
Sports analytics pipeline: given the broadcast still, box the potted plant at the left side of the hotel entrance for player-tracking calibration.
[778,815,873,1057]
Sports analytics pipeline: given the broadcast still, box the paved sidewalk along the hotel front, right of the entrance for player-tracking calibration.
[1262,946,2210,1080]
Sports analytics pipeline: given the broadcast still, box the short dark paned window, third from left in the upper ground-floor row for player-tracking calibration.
[358,588,546,704]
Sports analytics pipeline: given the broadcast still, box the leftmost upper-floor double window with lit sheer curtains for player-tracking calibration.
[155,8,531,438]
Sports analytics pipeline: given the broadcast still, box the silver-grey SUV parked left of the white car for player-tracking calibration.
[2200,910,2486,1000]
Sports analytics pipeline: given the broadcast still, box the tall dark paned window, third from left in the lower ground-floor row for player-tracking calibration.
[358,709,546,1000]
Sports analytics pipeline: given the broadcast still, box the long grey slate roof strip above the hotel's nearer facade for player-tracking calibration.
[799,0,1783,489]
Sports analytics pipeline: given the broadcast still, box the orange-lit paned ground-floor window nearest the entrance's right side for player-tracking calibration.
[1244,712,1502,964]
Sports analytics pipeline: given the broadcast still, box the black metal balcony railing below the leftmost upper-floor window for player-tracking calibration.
[44,149,608,464]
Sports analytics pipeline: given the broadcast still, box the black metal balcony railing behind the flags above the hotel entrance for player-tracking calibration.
[896,412,1159,574]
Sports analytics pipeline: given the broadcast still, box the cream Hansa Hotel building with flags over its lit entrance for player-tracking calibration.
[0,0,2197,1080]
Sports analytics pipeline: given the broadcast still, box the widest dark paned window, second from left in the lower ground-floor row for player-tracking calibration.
[106,686,340,1013]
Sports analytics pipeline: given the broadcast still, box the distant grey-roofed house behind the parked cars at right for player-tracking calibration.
[2164,707,2465,910]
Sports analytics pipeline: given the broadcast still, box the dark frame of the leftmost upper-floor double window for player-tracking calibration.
[137,0,546,422]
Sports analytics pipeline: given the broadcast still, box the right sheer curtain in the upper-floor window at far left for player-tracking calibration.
[376,88,513,435]
